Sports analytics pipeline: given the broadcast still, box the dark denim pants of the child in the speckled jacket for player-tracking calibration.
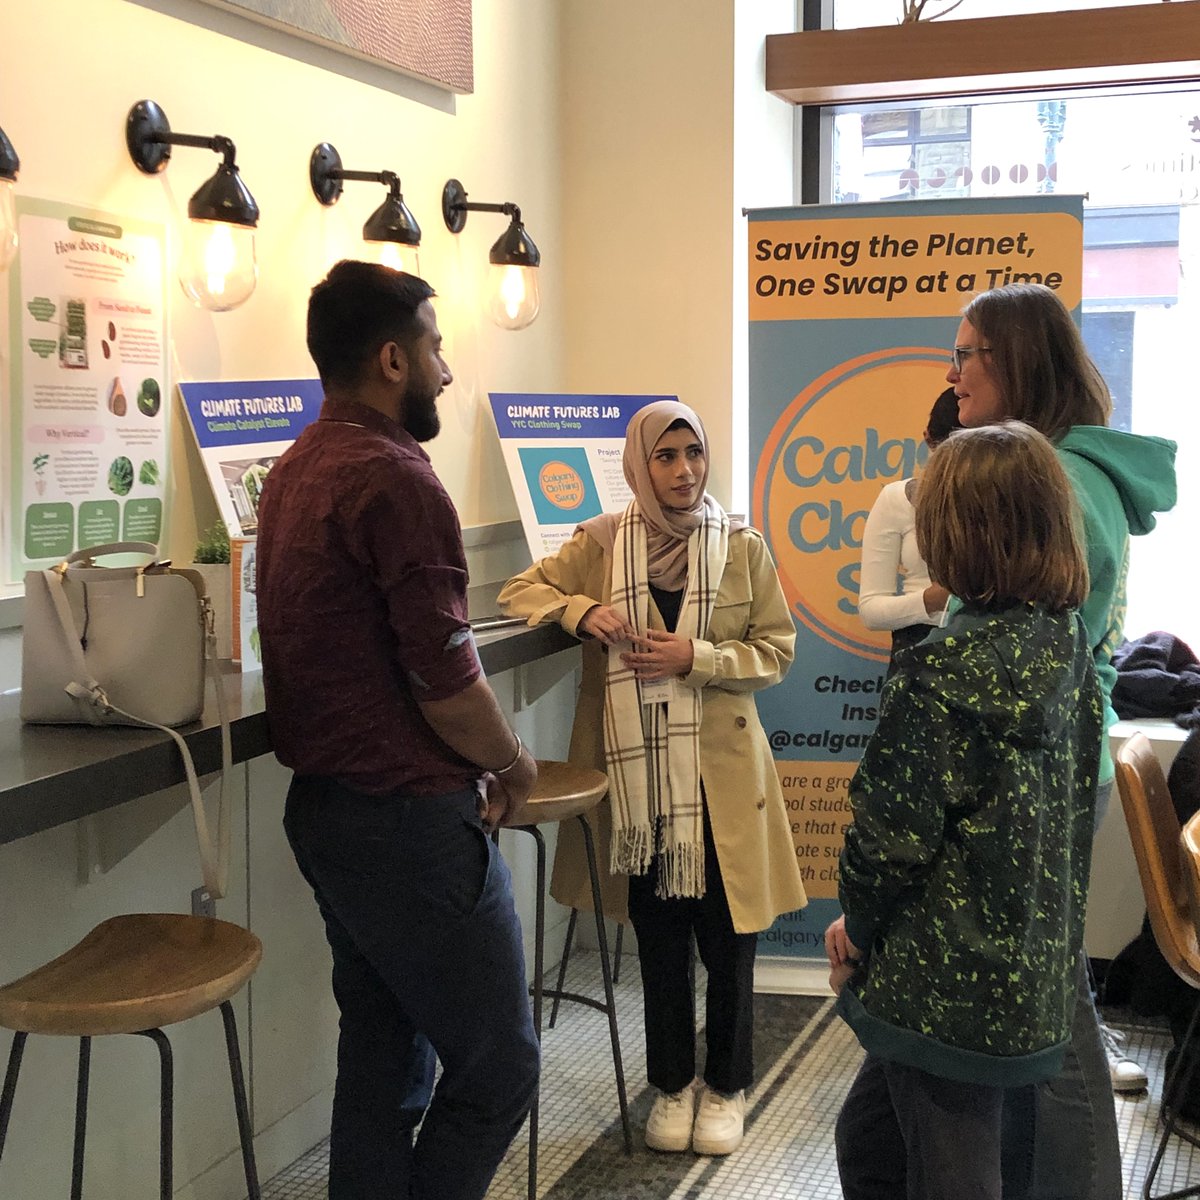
[836,1055,1006,1200]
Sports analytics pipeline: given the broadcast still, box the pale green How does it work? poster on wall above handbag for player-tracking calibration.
[2,196,170,583]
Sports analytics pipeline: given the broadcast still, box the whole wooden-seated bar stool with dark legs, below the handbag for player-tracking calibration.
[0,913,263,1200]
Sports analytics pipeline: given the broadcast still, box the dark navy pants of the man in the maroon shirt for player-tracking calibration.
[284,775,539,1200]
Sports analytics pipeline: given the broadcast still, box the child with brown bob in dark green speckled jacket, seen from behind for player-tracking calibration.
[826,421,1104,1200]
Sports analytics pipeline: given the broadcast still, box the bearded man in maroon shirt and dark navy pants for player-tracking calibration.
[257,262,539,1200]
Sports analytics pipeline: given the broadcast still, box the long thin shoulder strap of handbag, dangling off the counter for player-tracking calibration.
[42,566,233,900]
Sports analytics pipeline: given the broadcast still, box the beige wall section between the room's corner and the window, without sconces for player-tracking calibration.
[562,0,794,508]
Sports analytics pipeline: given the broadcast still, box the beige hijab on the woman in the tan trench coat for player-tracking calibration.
[580,400,743,592]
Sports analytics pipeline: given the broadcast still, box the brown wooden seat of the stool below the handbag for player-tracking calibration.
[0,913,263,1038]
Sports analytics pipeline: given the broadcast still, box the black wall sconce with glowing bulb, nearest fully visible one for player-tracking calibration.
[125,100,258,312]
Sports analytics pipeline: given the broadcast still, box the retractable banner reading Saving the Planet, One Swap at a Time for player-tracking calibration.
[749,196,1082,961]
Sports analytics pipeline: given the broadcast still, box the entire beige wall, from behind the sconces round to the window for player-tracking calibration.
[0,0,793,576]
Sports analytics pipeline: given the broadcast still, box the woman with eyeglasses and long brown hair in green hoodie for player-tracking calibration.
[946,283,1176,1200]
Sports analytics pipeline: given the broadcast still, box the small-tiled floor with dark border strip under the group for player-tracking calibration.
[263,953,1200,1200]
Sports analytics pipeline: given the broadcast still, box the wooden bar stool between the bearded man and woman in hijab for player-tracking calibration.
[506,760,634,1200]
